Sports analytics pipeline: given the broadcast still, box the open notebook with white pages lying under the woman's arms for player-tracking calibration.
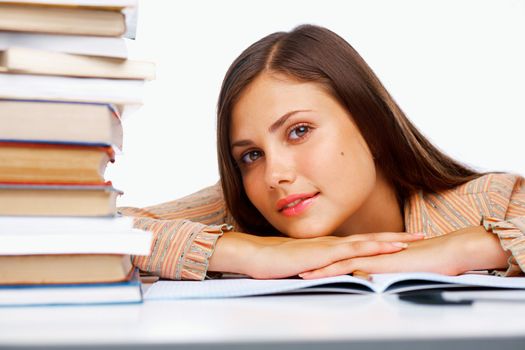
[144,272,525,300]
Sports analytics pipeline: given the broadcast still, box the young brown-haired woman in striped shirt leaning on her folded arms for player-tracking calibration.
[120,25,525,279]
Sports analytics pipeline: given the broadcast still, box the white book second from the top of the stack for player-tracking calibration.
[0,32,128,59]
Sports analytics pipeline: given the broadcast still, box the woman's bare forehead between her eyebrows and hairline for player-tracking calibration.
[230,74,337,136]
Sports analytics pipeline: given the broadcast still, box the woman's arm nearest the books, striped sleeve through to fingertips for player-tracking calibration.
[119,185,422,280]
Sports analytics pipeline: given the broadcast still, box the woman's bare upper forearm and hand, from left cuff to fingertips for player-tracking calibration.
[209,232,423,279]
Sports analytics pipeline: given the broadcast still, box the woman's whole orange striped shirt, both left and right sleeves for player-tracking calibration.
[119,174,525,280]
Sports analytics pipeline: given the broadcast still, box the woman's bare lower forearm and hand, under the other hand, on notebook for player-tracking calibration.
[300,226,510,279]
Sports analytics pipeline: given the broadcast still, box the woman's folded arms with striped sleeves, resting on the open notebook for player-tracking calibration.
[119,174,525,280]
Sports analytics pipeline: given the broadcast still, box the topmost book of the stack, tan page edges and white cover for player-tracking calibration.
[0,0,137,38]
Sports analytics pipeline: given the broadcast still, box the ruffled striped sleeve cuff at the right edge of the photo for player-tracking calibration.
[482,217,525,277]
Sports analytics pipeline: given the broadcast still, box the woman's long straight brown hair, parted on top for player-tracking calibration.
[217,25,481,235]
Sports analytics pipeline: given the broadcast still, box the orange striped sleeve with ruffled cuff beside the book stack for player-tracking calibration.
[118,184,233,280]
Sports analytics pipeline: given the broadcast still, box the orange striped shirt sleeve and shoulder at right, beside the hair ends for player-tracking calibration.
[405,173,525,276]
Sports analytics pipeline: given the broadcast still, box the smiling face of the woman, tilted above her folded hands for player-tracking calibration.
[230,74,376,238]
